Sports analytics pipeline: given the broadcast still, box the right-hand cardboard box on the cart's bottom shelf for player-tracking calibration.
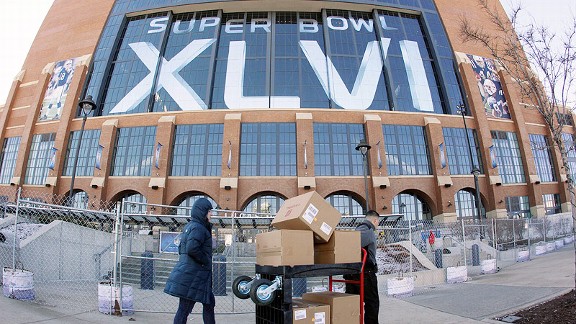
[302,291,360,324]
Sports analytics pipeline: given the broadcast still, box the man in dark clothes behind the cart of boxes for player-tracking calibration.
[344,210,380,324]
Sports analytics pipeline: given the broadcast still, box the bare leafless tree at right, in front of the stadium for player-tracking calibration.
[460,0,576,294]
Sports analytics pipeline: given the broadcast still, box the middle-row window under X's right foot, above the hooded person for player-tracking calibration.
[170,124,224,176]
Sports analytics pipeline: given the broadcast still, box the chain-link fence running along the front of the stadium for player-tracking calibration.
[0,187,574,314]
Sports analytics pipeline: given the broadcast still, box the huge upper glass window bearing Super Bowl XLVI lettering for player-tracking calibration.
[87,8,462,115]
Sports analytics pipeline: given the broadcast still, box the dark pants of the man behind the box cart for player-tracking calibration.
[344,272,380,324]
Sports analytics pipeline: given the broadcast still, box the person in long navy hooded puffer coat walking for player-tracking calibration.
[164,198,216,324]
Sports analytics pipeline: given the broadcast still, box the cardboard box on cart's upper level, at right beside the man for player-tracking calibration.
[314,230,362,264]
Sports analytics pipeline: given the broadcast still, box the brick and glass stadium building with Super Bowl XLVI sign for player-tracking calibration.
[0,0,574,221]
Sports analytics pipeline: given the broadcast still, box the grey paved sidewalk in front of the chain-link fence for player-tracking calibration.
[0,245,575,324]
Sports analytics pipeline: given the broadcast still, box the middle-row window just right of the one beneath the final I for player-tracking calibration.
[442,128,484,174]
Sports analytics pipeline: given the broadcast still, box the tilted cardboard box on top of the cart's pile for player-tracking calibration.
[272,191,342,242]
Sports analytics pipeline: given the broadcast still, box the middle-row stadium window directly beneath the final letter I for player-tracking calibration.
[382,125,432,175]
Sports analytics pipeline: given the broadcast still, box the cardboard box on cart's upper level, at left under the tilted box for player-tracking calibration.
[256,230,314,266]
